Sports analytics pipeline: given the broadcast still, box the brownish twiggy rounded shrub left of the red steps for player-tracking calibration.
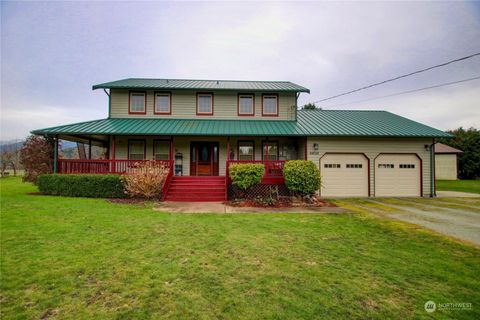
[124,161,169,199]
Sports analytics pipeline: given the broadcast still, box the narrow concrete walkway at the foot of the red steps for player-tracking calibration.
[154,201,347,213]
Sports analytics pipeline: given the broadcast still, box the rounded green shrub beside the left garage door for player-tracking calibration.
[283,160,321,197]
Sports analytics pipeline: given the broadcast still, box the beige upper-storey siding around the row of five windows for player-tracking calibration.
[110,90,296,120]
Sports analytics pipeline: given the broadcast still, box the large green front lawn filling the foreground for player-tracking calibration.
[0,178,480,319]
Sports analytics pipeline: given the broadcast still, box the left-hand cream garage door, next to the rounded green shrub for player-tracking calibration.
[320,154,368,197]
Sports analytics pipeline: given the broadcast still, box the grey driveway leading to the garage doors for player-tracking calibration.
[343,198,480,246]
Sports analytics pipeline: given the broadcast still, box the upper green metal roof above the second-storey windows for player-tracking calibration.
[92,78,310,92]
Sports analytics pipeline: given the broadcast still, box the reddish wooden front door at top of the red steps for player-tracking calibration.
[190,142,219,176]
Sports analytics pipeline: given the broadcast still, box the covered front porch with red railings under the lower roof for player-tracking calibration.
[55,135,306,180]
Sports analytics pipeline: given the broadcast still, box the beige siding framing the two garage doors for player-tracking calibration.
[308,137,431,196]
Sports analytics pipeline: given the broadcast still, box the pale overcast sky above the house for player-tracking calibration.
[1,1,480,140]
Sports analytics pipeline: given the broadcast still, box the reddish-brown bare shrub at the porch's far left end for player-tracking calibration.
[20,136,54,183]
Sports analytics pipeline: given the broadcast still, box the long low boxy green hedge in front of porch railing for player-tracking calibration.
[37,174,125,198]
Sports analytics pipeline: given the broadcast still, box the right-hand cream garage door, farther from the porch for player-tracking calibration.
[375,154,420,197]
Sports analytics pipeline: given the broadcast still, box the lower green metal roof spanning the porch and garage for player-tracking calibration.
[32,110,451,137]
